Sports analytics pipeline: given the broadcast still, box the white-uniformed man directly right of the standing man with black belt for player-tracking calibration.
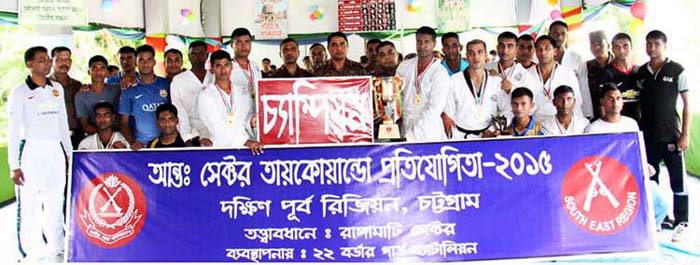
[486,31,537,95]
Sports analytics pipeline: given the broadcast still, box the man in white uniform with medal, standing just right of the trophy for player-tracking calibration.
[396,27,450,142]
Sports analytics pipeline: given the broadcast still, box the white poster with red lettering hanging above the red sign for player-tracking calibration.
[253,0,289,40]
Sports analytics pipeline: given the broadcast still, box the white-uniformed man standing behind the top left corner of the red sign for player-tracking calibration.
[231,28,262,97]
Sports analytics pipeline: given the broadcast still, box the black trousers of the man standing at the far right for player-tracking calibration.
[644,137,688,224]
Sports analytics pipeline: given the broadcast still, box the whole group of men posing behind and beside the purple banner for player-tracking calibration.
[8,21,690,259]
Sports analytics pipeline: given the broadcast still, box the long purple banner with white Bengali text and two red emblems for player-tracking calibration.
[68,133,654,262]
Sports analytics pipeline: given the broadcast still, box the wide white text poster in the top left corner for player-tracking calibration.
[17,0,88,26]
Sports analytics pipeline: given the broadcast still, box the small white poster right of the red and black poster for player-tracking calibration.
[436,0,470,32]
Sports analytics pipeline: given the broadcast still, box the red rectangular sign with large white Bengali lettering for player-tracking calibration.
[257,77,372,144]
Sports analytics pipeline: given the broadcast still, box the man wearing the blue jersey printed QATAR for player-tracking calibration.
[119,45,170,150]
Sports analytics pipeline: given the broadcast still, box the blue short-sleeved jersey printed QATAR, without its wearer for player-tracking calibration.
[119,77,170,144]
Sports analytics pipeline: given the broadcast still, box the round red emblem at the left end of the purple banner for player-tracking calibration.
[76,173,146,248]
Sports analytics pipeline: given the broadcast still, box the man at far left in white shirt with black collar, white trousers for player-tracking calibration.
[8,47,73,262]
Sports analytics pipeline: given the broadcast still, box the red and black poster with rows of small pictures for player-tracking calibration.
[338,0,396,32]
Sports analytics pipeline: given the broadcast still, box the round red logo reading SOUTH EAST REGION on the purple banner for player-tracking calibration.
[561,156,641,235]
